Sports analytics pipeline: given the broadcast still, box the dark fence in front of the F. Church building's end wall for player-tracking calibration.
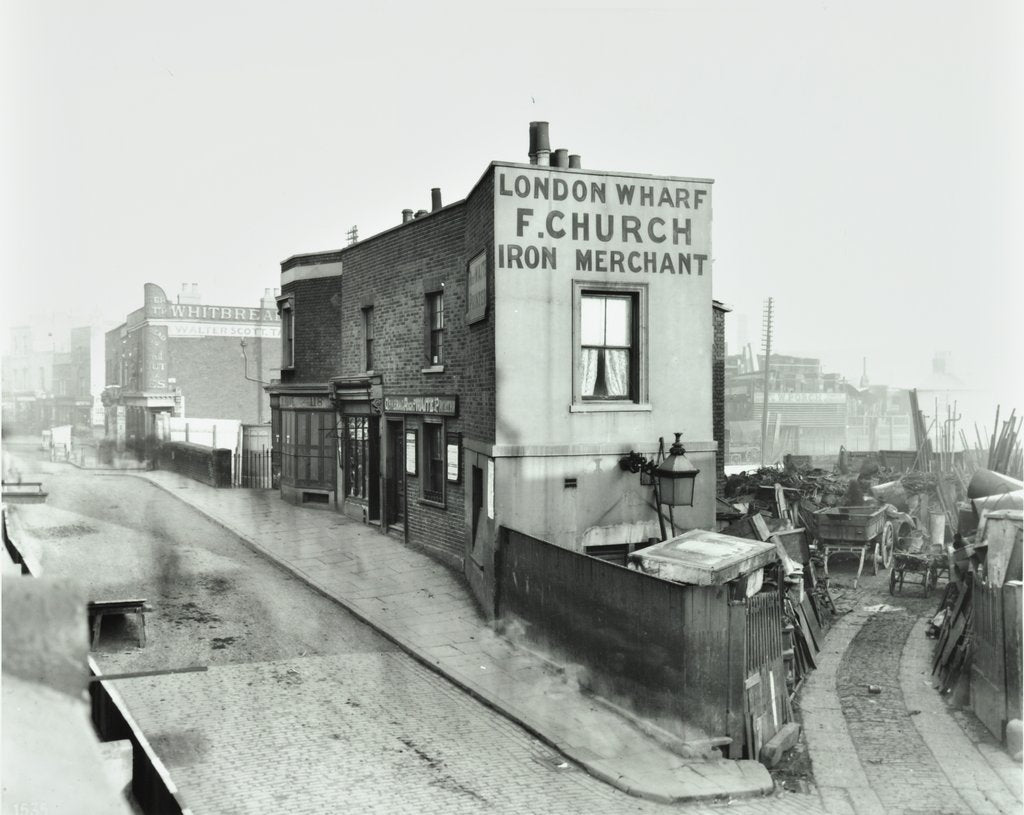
[496,528,787,758]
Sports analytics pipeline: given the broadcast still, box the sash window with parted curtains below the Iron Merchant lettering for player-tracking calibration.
[579,292,637,400]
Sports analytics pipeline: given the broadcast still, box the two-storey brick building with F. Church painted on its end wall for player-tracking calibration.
[268,124,725,602]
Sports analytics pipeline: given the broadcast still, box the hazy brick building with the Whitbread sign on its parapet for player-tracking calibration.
[102,283,281,447]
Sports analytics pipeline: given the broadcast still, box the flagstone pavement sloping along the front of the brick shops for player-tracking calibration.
[112,472,818,812]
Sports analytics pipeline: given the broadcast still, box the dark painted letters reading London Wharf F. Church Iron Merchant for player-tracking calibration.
[497,173,708,275]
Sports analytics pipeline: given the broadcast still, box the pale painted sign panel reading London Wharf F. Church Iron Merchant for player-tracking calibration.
[495,171,711,277]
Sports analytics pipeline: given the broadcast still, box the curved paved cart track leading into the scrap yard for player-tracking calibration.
[798,576,1022,815]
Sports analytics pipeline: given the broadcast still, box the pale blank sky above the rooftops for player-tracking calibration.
[0,0,1024,408]
